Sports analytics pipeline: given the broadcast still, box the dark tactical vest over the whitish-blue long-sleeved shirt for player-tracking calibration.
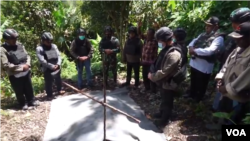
[194,32,225,63]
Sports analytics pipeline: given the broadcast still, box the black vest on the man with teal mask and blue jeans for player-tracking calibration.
[75,39,90,56]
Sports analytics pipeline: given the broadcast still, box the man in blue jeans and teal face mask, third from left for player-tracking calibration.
[70,28,94,89]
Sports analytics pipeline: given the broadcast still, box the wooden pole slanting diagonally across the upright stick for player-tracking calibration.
[62,82,141,123]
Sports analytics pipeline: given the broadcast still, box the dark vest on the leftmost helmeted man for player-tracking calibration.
[3,43,28,65]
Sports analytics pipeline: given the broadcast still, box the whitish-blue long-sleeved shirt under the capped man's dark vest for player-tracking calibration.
[188,36,224,74]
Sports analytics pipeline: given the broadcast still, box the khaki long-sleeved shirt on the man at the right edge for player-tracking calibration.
[216,47,250,102]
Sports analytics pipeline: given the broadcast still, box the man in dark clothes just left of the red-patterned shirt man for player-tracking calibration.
[122,26,143,89]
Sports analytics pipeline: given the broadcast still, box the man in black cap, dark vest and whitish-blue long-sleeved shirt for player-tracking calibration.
[187,16,224,102]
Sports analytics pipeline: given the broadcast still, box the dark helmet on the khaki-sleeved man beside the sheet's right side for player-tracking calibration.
[155,27,174,41]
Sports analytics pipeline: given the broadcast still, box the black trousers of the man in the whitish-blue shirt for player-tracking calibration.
[190,67,211,102]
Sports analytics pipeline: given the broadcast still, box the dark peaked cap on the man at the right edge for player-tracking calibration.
[228,22,250,38]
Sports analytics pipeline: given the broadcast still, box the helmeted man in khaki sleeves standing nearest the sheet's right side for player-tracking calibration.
[148,27,185,127]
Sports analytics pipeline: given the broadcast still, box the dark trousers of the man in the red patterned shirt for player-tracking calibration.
[142,65,156,93]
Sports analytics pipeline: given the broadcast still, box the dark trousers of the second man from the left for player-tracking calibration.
[44,71,62,96]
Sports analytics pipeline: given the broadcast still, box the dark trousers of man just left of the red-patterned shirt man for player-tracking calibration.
[126,62,140,86]
